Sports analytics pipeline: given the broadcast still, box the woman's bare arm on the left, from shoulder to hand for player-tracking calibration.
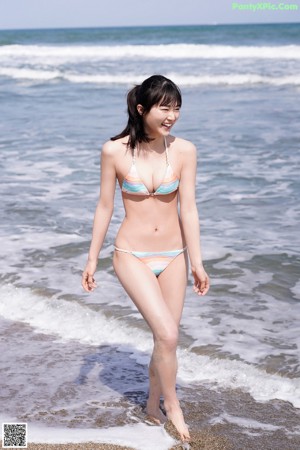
[81,142,116,292]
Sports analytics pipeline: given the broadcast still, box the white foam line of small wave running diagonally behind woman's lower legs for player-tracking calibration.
[0,285,300,407]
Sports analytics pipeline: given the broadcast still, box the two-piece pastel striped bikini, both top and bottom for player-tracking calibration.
[115,140,186,277]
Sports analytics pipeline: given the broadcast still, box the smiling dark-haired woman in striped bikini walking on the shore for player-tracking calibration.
[82,75,209,441]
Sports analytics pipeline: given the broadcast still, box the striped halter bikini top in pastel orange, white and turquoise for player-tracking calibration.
[121,141,179,197]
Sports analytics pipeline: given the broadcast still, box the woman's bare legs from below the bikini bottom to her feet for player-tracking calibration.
[113,252,189,439]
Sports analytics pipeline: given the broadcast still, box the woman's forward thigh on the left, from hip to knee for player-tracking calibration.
[113,251,177,339]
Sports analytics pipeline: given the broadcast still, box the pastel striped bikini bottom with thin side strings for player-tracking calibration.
[115,247,186,277]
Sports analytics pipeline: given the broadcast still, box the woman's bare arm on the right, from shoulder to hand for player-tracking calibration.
[179,142,209,295]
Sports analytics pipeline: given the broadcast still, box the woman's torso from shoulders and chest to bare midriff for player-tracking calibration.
[115,137,185,251]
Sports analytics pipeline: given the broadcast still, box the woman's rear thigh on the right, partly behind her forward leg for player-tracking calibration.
[158,251,188,326]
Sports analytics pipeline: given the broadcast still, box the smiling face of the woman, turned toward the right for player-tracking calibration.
[138,105,180,138]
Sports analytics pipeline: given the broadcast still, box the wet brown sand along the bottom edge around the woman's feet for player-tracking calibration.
[0,387,300,450]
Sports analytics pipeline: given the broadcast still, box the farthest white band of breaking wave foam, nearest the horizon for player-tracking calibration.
[0,43,300,60]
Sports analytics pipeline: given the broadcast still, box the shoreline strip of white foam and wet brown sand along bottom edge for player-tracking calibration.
[1,386,300,450]
